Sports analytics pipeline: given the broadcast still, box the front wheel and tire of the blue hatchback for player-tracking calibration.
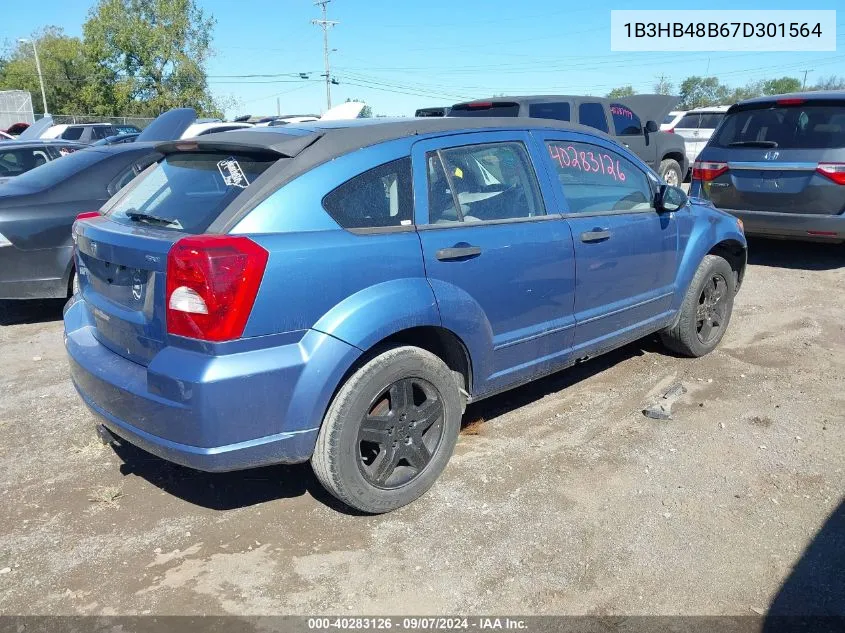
[660,255,736,357]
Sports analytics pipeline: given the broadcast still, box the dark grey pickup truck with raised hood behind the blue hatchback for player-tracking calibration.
[449,95,688,186]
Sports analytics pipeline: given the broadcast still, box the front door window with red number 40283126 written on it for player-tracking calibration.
[546,141,654,214]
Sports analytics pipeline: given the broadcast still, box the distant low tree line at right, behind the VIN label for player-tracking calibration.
[607,75,845,110]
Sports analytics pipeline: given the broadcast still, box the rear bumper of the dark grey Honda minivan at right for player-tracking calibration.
[722,209,845,242]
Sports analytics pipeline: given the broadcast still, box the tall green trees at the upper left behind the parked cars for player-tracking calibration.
[0,0,224,117]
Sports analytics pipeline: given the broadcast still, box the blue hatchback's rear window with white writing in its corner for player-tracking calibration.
[109,153,275,233]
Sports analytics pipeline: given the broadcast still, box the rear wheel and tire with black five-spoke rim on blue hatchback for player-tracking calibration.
[311,346,463,514]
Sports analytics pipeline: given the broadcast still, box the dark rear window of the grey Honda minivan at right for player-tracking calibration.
[711,105,845,149]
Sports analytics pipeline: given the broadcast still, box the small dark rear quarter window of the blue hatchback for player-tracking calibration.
[323,158,414,229]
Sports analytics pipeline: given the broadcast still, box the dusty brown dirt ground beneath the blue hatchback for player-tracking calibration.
[0,236,845,615]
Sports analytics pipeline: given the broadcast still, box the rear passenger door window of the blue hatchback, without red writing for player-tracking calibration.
[426,142,545,224]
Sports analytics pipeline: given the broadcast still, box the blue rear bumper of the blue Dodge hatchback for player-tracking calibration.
[65,300,356,471]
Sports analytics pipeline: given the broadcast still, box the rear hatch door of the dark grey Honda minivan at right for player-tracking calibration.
[699,101,845,215]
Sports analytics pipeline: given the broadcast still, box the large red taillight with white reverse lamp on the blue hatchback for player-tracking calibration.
[166,235,268,341]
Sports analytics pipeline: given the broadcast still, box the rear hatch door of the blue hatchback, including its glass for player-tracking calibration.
[74,148,280,365]
